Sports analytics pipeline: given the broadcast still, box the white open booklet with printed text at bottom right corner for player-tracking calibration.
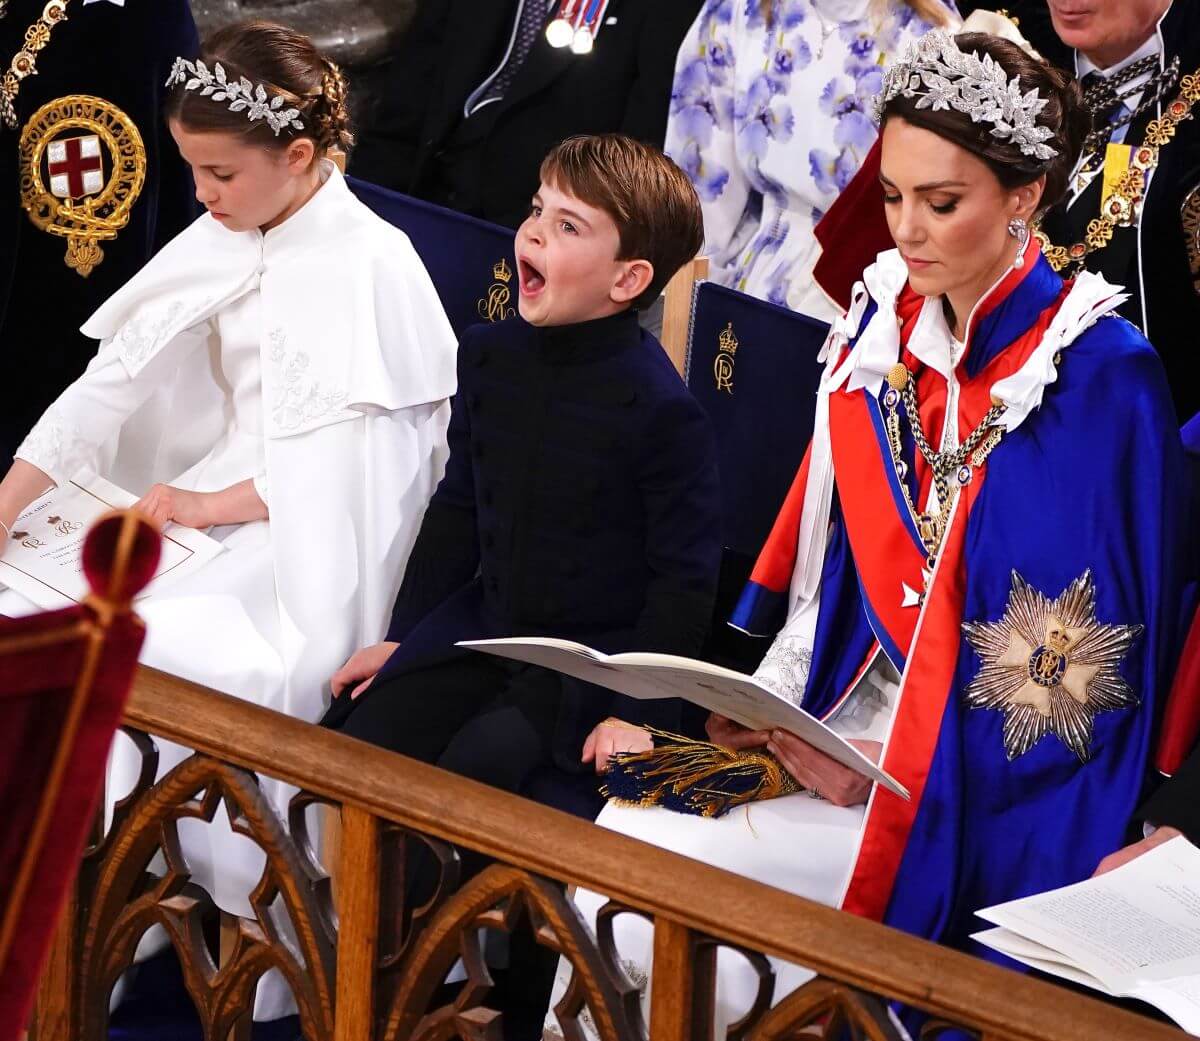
[973,837,1200,1035]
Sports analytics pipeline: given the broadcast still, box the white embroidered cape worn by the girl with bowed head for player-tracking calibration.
[17,163,456,716]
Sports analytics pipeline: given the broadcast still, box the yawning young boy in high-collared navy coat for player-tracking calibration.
[325,136,721,805]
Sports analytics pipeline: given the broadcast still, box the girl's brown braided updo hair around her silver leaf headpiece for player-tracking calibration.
[167,20,354,156]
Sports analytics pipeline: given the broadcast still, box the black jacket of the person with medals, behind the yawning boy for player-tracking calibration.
[350,0,701,227]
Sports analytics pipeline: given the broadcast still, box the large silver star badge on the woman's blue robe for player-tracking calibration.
[962,570,1144,763]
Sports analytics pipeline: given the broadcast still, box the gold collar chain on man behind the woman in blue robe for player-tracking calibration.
[1033,62,1200,277]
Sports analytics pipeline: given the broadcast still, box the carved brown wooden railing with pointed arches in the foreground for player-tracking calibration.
[31,670,1184,1041]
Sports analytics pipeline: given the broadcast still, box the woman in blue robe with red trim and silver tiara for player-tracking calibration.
[547,31,1193,1028]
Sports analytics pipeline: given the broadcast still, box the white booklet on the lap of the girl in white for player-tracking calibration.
[0,475,221,610]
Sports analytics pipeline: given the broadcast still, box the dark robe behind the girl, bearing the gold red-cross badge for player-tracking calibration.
[0,0,199,474]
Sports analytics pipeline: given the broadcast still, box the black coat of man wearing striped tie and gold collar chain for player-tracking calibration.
[959,0,1200,423]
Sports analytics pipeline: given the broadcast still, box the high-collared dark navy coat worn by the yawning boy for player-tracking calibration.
[379,312,721,766]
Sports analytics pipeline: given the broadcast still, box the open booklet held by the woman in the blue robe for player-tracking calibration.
[458,637,908,799]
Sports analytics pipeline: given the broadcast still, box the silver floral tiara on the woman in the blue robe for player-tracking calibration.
[875,29,1058,162]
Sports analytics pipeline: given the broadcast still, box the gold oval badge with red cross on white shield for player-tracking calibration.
[20,94,146,278]
